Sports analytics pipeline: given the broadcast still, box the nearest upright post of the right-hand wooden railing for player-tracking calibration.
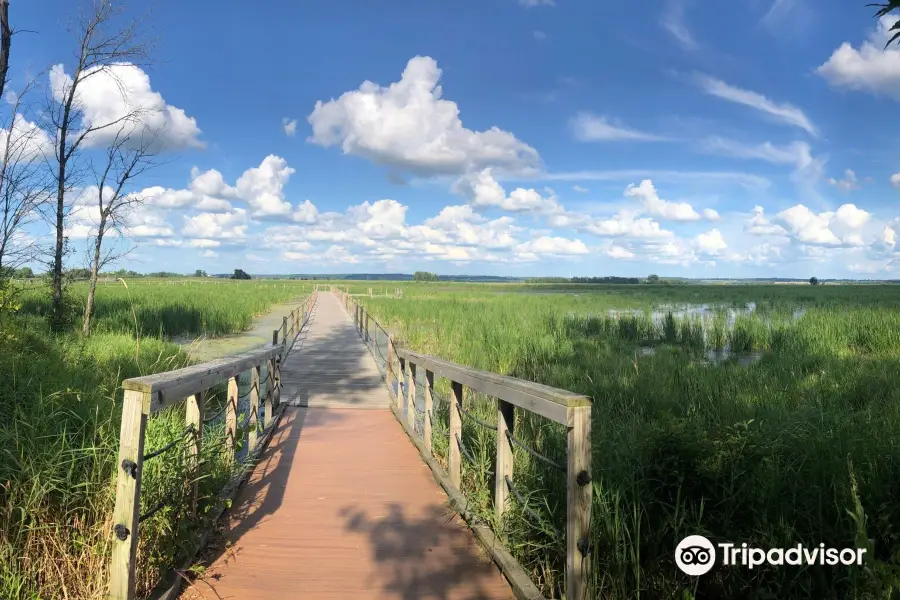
[566,406,593,600]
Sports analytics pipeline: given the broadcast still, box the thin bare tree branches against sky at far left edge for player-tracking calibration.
[0,81,51,280]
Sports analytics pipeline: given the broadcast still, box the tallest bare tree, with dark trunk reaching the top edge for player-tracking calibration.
[45,0,150,330]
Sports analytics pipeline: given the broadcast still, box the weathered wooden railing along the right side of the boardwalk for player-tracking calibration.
[332,287,593,600]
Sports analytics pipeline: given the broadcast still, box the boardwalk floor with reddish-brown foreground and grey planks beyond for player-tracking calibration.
[182,293,512,600]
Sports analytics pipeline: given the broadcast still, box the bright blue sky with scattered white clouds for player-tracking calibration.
[10,0,900,278]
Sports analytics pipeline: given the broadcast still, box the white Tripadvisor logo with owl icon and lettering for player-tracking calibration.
[675,535,866,577]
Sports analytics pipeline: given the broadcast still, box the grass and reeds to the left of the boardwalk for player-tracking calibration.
[0,280,313,600]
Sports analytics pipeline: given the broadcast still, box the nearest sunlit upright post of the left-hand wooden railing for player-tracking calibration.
[109,390,150,600]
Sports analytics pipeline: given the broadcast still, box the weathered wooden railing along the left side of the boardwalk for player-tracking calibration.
[108,291,318,600]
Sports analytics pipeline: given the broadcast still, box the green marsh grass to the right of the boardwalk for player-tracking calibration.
[351,284,900,598]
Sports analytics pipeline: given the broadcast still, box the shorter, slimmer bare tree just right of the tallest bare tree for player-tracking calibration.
[81,115,160,335]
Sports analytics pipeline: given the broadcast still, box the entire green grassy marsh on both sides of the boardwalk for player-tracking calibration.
[7,280,900,599]
